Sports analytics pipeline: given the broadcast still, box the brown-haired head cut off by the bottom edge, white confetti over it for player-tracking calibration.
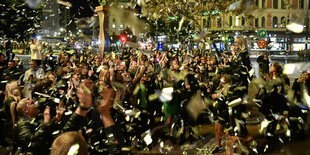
[51,131,88,155]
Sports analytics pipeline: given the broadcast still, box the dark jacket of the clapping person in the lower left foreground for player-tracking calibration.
[13,113,84,155]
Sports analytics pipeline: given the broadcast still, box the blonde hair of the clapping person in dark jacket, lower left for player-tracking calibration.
[10,98,28,127]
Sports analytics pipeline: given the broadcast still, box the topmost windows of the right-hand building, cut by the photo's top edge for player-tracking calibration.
[255,0,310,9]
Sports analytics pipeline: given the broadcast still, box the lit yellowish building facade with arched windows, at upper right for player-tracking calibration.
[201,0,310,53]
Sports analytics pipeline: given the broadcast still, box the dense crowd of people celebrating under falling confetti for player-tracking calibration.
[0,37,310,154]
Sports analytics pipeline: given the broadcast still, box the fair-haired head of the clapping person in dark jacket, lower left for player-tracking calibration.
[10,98,40,127]
